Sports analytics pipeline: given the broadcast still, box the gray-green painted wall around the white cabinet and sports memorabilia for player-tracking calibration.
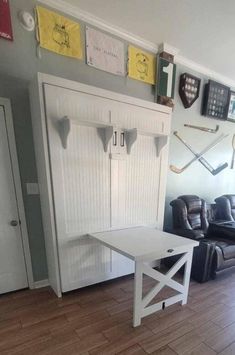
[0,0,235,280]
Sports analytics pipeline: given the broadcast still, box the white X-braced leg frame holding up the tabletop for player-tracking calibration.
[133,249,193,327]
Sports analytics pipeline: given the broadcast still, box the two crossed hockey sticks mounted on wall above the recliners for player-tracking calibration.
[170,132,228,175]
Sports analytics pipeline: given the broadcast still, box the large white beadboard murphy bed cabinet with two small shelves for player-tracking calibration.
[30,73,171,296]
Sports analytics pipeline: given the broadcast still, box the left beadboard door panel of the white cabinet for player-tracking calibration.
[45,87,115,292]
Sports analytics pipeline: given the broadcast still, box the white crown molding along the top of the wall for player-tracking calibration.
[39,0,235,88]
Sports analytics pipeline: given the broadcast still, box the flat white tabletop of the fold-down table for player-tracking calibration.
[89,227,199,261]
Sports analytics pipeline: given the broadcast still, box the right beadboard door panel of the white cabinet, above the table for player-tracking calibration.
[111,104,163,228]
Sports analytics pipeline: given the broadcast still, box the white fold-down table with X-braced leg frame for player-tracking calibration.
[89,227,199,327]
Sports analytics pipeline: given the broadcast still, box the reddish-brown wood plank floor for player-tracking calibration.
[0,270,235,355]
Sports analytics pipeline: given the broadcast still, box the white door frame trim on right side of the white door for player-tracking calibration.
[0,97,34,289]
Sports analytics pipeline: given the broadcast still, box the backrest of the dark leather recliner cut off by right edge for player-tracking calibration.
[215,195,235,221]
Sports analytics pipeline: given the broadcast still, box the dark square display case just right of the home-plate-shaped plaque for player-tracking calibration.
[202,80,229,120]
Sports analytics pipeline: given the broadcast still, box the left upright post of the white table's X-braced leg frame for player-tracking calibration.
[133,261,143,327]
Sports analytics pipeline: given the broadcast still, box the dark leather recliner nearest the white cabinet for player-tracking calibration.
[167,195,235,282]
